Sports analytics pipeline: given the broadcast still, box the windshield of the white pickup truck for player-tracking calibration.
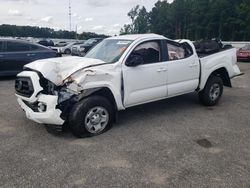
[85,39,133,63]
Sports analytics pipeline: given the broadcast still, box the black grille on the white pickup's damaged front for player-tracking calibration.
[15,77,34,97]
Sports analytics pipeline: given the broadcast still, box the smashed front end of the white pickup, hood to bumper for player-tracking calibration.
[15,55,118,130]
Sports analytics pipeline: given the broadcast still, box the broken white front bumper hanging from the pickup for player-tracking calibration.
[16,94,65,125]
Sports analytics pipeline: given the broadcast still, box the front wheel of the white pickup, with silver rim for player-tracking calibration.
[69,96,114,138]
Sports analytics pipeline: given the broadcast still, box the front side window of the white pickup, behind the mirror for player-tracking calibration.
[128,41,161,64]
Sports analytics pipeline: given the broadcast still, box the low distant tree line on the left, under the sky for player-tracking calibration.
[0,24,107,40]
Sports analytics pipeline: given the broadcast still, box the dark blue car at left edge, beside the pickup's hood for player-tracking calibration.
[0,39,57,76]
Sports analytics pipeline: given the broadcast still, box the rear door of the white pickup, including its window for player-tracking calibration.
[166,41,200,97]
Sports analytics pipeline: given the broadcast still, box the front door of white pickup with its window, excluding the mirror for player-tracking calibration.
[123,40,167,107]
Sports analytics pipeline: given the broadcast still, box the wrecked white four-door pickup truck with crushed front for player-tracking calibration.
[15,34,241,137]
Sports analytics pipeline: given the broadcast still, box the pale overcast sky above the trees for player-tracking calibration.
[0,0,163,35]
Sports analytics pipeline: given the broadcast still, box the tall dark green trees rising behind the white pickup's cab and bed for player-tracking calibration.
[120,0,250,41]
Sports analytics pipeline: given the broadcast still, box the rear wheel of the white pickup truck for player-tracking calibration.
[199,76,223,106]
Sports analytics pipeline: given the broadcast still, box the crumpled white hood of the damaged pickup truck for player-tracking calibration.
[24,56,105,85]
